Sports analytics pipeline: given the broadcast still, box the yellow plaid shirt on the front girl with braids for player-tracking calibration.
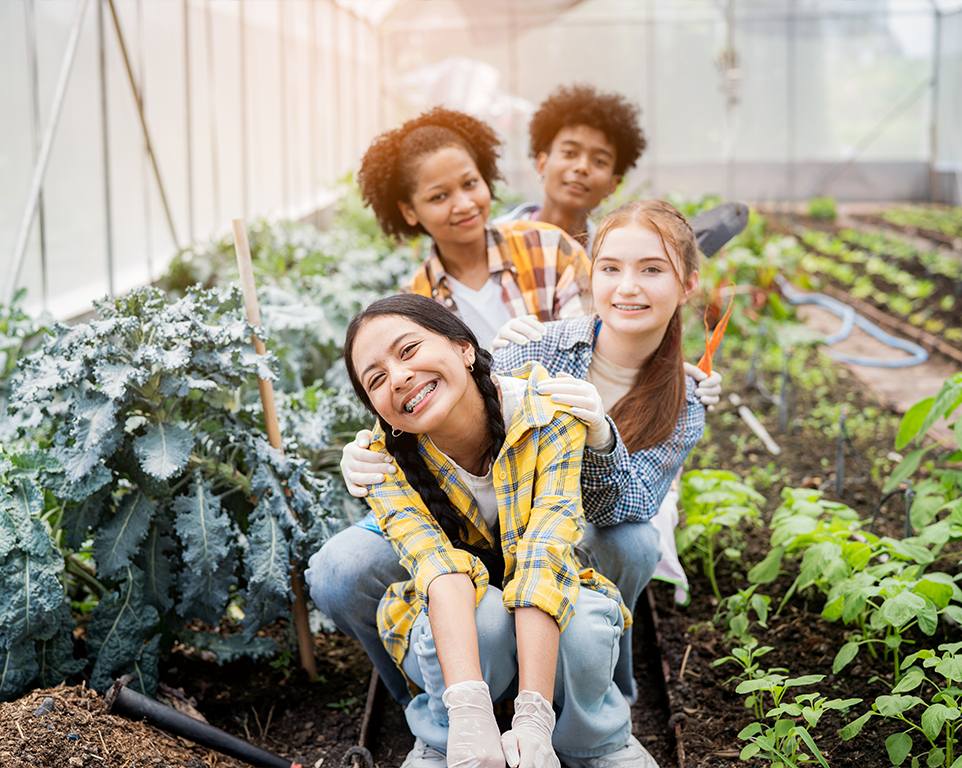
[368,363,631,666]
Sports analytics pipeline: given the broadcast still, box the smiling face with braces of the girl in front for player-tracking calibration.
[352,315,478,435]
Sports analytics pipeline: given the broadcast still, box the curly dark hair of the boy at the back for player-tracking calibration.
[528,83,648,176]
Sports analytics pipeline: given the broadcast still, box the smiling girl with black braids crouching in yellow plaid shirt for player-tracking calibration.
[344,295,648,768]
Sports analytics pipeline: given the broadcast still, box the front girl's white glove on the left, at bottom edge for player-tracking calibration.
[441,680,504,768]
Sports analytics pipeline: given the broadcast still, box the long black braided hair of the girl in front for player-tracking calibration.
[344,293,506,586]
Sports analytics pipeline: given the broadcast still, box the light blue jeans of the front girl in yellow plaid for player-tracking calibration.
[402,586,631,757]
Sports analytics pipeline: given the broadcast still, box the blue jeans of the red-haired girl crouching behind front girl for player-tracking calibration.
[304,523,661,704]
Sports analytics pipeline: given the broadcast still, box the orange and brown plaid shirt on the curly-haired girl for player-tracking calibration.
[401,221,591,322]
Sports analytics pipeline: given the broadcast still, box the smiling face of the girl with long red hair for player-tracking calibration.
[591,224,698,342]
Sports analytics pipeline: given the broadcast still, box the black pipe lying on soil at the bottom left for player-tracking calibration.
[106,678,301,768]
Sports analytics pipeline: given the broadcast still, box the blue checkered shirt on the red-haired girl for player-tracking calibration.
[493,315,705,526]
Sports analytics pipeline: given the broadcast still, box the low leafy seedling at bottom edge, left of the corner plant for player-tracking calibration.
[735,674,862,768]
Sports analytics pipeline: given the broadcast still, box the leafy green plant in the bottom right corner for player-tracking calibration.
[841,643,962,768]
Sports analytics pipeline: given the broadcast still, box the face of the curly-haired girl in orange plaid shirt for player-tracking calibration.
[398,146,491,253]
